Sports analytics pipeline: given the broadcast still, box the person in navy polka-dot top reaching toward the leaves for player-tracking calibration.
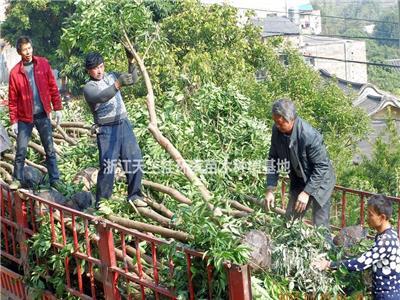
[311,195,400,300]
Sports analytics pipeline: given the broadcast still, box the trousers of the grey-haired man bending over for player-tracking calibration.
[286,187,331,229]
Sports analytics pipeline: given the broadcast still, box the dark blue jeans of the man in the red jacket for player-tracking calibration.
[14,113,60,183]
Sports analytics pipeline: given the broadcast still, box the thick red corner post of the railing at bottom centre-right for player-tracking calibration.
[227,265,252,300]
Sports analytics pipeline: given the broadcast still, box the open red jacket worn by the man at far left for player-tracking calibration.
[8,56,62,124]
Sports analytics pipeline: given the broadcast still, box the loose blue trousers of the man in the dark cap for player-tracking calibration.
[96,119,143,206]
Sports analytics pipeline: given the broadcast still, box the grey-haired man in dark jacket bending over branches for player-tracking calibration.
[265,99,336,227]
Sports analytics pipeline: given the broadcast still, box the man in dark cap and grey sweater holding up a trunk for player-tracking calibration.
[83,51,147,208]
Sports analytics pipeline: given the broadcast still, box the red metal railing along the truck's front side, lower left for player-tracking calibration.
[0,183,251,300]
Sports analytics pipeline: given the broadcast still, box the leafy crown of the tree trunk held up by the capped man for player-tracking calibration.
[59,0,155,91]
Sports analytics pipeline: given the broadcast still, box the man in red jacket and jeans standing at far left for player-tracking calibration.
[8,36,62,190]
